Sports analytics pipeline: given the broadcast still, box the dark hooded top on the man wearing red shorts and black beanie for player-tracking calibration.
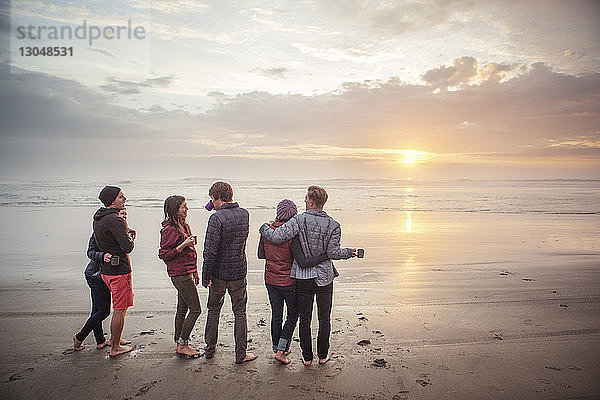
[94,207,133,275]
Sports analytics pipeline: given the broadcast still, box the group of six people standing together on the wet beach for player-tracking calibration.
[73,182,363,365]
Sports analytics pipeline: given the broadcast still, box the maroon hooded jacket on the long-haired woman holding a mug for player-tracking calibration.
[158,221,198,276]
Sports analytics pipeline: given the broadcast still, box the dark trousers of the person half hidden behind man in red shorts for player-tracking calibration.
[75,276,110,344]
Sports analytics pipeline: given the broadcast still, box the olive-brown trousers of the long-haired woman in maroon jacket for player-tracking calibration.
[171,273,202,345]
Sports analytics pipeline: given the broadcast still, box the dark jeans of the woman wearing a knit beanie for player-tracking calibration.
[265,283,298,353]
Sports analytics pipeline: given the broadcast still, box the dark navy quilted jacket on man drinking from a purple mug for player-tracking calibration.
[202,203,250,287]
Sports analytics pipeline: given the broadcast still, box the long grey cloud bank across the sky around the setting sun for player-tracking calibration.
[0,57,600,178]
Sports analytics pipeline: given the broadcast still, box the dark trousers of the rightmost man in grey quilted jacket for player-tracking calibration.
[296,279,333,361]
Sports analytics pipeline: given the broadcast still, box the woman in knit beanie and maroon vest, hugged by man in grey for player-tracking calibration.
[258,199,327,364]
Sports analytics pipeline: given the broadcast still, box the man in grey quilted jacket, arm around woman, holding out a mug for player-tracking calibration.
[260,186,356,365]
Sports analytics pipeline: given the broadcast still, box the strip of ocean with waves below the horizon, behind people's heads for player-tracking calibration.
[0,178,600,214]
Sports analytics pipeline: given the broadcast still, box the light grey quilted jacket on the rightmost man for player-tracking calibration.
[260,210,352,286]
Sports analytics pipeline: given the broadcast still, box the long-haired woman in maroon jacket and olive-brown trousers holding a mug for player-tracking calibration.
[158,196,202,357]
